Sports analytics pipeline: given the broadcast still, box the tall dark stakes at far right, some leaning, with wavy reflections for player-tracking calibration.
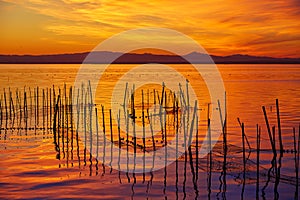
[237,99,300,199]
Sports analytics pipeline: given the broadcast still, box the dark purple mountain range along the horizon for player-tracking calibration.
[0,51,300,64]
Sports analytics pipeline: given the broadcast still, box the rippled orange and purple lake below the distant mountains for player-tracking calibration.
[0,64,300,199]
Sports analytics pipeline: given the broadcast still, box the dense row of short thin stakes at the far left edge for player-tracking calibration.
[0,85,65,135]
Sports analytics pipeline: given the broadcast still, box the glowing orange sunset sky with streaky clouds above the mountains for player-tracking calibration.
[0,0,300,57]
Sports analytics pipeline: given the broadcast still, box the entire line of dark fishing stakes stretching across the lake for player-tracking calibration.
[0,84,300,199]
